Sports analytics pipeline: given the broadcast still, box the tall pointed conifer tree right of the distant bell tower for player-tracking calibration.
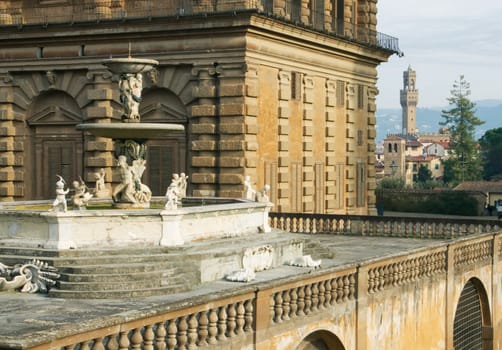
[439,75,484,185]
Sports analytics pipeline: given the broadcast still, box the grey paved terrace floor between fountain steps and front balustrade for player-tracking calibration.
[0,232,452,348]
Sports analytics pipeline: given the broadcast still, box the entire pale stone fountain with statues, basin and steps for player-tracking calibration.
[0,57,314,298]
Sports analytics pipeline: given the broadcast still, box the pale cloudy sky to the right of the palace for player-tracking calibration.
[377,0,502,108]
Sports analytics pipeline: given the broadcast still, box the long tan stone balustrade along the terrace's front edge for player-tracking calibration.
[9,231,502,350]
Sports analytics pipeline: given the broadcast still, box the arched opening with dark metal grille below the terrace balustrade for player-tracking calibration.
[453,278,493,350]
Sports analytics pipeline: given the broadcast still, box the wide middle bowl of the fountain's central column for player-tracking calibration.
[76,123,185,140]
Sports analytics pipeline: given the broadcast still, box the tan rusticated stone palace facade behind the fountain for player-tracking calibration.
[0,0,399,214]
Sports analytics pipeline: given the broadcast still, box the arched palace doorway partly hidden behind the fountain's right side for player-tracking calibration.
[140,88,190,196]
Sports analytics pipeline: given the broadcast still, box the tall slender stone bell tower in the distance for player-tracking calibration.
[401,66,418,135]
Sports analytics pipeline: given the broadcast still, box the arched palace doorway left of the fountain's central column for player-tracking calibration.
[24,90,83,199]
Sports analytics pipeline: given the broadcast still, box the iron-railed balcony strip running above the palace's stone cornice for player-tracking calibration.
[0,0,401,54]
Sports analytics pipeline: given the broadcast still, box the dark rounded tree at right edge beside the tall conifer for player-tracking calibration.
[479,128,502,180]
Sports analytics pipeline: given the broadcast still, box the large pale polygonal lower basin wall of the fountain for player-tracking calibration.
[0,200,271,250]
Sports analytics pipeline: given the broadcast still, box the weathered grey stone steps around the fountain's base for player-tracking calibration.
[0,232,329,299]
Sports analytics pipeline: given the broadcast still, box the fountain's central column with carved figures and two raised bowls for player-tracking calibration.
[77,57,184,209]
